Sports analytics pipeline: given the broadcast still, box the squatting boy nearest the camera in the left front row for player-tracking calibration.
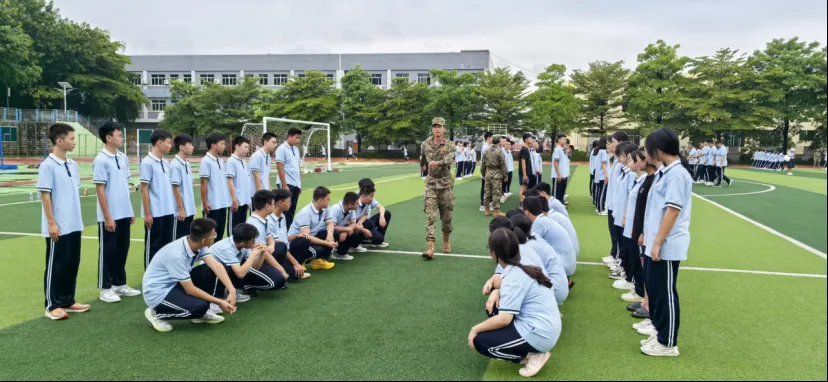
[142,219,236,333]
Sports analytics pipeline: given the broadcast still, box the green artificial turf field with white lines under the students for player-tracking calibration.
[0,163,828,380]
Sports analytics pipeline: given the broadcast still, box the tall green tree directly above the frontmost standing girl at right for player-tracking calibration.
[625,40,690,131]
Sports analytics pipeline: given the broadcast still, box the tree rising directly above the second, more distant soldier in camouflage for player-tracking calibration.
[477,68,529,129]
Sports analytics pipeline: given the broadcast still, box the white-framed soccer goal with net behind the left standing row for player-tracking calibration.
[242,117,332,173]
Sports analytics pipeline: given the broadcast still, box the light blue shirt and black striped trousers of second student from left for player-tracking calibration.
[92,149,135,289]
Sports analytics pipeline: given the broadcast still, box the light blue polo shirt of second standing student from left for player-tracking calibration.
[92,149,135,223]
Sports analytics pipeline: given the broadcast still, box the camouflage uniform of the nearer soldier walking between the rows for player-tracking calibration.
[422,128,454,242]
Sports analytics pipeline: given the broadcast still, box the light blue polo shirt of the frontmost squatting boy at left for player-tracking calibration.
[142,236,210,309]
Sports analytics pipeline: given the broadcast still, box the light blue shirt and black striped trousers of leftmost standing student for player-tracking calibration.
[37,154,83,312]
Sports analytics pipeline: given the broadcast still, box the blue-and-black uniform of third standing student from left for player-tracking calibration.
[140,153,178,268]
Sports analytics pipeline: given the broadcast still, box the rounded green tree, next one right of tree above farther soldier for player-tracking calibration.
[526,64,579,136]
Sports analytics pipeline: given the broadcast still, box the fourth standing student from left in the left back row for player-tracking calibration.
[170,133,196,240]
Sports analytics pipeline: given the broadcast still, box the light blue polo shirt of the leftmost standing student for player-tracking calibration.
[37,154,83,237]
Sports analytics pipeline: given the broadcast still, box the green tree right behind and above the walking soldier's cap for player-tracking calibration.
[422,70,480,136]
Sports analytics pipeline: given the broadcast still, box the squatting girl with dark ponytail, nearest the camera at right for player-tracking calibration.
[469,228,561,377]
